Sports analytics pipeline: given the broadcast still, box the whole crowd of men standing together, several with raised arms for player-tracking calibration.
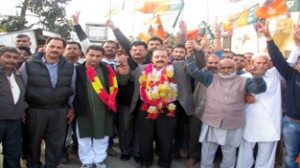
[0,12,300,168]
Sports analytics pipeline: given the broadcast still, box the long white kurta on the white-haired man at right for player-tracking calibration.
[243,68,282,142]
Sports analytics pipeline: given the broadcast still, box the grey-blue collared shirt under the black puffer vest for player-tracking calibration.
[20,56,76,107]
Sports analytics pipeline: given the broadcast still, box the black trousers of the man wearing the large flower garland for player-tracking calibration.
[138,104,177,167]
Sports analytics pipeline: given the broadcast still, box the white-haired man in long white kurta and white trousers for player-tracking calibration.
[237,53,282,168]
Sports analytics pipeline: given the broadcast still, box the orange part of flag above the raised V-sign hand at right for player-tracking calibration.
[255,0,288,19]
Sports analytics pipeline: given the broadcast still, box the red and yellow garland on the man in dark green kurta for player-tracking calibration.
[86,65,118,112]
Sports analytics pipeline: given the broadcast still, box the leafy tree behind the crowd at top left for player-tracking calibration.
[0,0,72,39]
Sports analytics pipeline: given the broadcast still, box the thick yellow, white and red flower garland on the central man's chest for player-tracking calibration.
[139,64,177,120]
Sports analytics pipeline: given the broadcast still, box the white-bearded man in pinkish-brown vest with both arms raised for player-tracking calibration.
[186,56,266,168]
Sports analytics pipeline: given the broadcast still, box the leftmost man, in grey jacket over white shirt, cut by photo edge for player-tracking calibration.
[0,47,28,168]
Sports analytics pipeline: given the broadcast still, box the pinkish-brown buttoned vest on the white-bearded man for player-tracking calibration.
[201,75,247,129]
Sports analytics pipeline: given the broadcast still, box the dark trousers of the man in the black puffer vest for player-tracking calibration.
[26,108,67,168]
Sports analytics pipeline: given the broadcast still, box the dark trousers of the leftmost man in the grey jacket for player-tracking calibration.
[0,119,22,168]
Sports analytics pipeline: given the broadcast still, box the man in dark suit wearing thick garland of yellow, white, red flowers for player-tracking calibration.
[130,49,194,168]
